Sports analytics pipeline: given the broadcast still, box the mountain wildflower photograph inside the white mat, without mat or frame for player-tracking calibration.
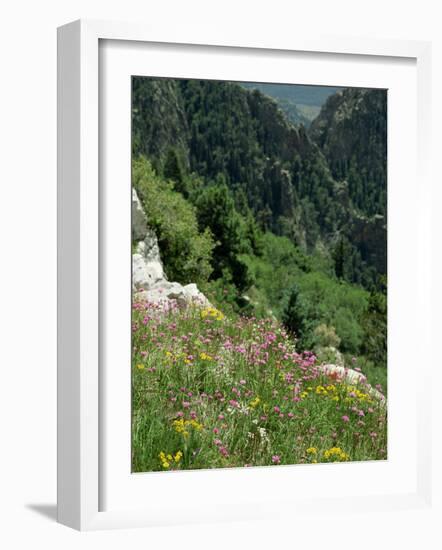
[130,75,388,473]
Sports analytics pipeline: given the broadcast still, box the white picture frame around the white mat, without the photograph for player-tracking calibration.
[58,21,431,530]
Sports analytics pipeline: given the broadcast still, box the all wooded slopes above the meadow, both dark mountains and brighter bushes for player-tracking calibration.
[133,78,386,374]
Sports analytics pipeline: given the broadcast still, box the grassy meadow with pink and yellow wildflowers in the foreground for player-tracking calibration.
[132,303,387,472]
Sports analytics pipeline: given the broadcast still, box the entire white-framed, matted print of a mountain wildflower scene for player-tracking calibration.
[58,21,431,529]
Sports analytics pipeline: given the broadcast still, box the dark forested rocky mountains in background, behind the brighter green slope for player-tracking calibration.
[132,77,386,294]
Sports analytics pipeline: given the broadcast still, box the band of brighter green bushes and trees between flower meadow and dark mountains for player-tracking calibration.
[133,157,386,378]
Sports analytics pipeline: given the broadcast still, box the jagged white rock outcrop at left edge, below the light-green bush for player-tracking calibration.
[132,189,210,307]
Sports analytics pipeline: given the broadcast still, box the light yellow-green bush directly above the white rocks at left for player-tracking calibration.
[132,157,214,284]
